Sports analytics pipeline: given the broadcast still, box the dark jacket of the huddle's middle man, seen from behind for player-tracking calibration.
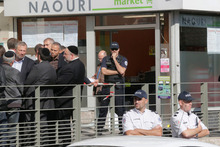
[24,61,56,109]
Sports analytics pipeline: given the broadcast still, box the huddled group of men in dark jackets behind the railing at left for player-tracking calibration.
[0,38,85,143]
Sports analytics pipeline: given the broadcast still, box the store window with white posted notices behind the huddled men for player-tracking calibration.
[17,16,86,65]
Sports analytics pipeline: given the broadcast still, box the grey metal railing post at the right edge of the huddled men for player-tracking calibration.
[71,85,81,141]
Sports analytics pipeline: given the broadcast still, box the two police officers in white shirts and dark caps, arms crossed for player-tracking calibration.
[123,90,209,139]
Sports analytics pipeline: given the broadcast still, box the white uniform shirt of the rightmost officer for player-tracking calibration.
[170,109,207,138]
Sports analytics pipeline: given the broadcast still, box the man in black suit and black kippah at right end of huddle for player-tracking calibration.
[55,46,85,119]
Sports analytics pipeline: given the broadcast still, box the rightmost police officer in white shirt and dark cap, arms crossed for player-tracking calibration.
[170,91,209,138]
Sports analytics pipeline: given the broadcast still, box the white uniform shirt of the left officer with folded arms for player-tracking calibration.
[122,108,162,133]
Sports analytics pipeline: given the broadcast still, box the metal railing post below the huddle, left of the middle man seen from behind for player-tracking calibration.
[35,86,40,146]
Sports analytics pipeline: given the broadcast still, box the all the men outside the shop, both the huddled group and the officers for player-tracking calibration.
[0,38,209,146]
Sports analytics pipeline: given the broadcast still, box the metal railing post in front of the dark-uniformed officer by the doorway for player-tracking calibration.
[109,85,115,134]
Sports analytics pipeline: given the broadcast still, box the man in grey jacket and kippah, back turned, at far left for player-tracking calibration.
[0,51,23,145]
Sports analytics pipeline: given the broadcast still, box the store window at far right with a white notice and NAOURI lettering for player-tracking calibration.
[180,14,220,106]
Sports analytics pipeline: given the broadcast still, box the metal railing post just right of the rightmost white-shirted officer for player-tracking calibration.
[201,83,208,126]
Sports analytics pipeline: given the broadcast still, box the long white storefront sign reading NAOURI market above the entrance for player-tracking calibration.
[4,0,181,17]
